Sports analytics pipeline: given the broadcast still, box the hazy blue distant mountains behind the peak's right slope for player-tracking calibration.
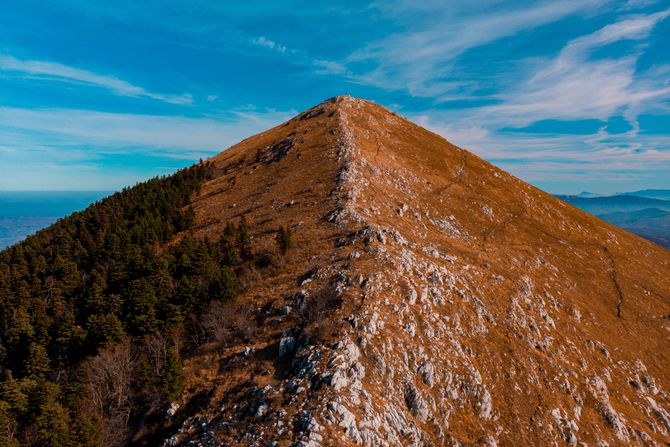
[556,189,670,249]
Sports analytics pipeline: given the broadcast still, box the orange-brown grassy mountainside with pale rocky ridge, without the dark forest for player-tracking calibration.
[5,96,670,447]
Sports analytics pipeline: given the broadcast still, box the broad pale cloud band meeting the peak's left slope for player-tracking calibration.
[0,107,294,157]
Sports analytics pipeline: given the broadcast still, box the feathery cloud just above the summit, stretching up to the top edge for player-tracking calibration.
[346,0,603,97]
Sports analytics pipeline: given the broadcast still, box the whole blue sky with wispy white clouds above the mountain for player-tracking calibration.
[0,0,670,193]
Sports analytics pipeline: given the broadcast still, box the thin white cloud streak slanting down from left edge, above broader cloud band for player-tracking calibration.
[0,54,193,104]
